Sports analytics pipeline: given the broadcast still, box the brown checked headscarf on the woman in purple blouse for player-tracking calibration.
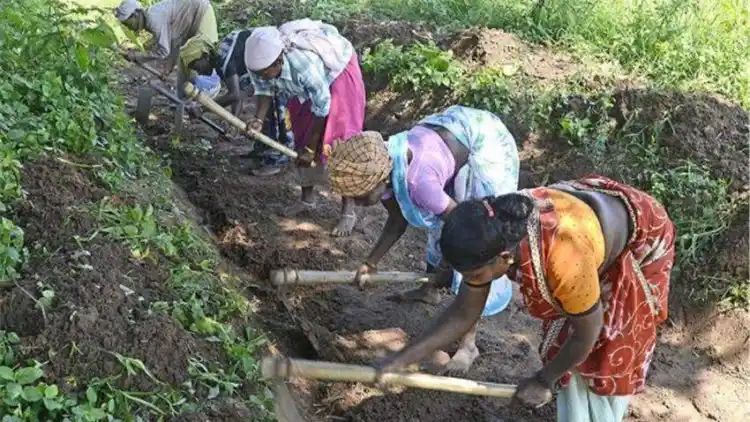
[328,131,392,198]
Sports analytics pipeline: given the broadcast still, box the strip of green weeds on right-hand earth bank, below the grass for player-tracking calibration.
[363,27,750,304]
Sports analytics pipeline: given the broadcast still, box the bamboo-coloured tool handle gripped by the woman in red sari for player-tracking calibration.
[261,358,516,398]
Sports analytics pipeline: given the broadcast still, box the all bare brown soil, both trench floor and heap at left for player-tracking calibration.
[0,2,750,422]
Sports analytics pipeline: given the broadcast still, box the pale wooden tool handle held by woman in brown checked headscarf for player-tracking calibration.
[270,268,428,287]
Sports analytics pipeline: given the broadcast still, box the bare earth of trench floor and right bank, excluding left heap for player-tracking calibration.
[113,18,750,421]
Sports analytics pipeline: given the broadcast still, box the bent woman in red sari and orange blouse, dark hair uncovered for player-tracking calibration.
[378,176,675,421]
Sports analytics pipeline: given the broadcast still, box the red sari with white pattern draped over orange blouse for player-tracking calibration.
[519,176,675,396]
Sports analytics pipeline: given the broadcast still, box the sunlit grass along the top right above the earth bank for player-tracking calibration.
[268,0,750,108]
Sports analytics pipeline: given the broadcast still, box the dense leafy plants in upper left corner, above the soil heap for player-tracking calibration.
[0,0,147,282]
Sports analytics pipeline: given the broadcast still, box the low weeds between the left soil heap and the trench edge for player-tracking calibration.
[97,197,270,417]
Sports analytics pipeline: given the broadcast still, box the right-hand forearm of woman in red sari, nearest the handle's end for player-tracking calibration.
[539,302,604,387]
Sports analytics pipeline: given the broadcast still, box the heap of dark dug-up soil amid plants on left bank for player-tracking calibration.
[0,158,222,396]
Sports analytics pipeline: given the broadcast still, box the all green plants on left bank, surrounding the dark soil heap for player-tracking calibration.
[0,0,271,421]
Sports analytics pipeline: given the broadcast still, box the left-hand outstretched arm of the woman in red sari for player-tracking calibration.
[377,283,490,372]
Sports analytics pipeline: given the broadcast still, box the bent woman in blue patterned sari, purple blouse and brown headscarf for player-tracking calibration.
[329,106,519,371]
